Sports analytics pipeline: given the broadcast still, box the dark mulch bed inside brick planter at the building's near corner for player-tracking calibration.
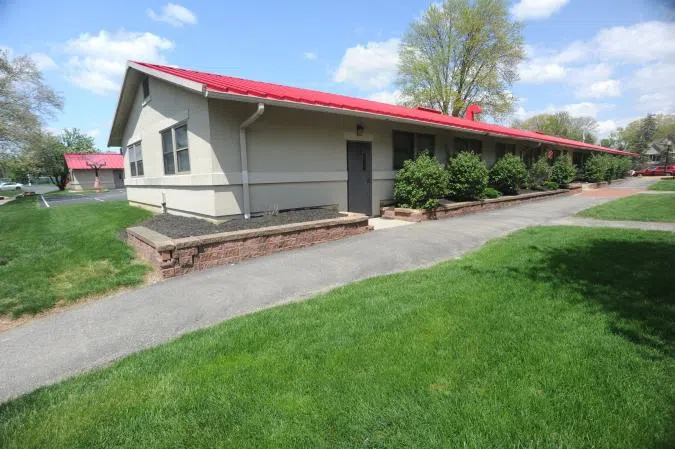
[138,209,345,239]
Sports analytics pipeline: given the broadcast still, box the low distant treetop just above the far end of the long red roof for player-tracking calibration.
[512,112,598,143]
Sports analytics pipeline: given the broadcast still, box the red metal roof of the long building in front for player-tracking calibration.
[135,62,635,156]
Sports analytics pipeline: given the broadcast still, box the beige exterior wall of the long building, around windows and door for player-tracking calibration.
[124,75,588,217]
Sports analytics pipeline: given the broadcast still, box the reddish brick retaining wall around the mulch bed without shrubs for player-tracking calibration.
[127,212,372,278]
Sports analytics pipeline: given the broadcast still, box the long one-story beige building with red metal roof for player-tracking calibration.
[108,62,631,218]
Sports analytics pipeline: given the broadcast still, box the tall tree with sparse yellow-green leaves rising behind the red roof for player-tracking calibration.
[398,0,525,117]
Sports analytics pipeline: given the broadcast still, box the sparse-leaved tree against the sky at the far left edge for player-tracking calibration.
[0,50,63,154]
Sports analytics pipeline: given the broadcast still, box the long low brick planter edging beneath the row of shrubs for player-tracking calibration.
[380,185,581,222]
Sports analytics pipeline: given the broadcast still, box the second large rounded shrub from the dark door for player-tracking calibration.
[447,151,488,201]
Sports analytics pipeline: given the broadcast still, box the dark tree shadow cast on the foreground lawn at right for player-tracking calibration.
[531,239,675,358]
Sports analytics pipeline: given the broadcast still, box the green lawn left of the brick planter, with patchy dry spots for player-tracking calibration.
[0,198,149,316]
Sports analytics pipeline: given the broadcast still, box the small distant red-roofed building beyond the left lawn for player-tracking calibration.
[64,153,124,190]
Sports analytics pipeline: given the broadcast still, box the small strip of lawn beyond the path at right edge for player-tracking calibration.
[577,194,675,222]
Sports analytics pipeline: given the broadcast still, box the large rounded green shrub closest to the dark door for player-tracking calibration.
[394,152,448,209]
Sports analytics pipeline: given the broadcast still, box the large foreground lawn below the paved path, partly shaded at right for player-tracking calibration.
[0,227,675,449]
